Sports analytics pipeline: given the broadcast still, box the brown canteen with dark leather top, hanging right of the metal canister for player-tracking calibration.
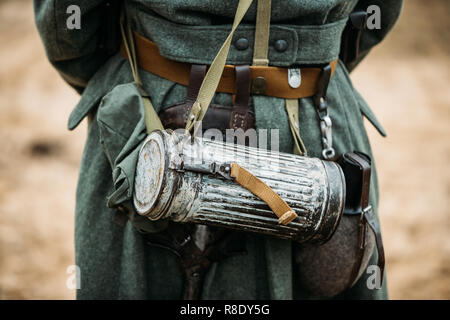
[293,152,384,298]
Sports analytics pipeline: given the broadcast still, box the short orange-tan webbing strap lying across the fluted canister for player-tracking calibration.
[230,163,297,225]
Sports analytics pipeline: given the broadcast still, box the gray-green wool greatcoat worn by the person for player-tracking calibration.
[34,0,401,299]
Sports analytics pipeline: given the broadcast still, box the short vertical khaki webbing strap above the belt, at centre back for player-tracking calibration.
[253,0,271,66]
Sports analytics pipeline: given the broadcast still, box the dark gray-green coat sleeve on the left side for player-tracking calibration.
[34,0,120,93]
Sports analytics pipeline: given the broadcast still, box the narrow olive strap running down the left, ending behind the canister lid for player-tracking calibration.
[120,9,164,133]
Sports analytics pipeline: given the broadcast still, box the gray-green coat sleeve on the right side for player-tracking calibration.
[344,0,403,71]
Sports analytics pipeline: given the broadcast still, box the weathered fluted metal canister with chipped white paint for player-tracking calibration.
[134,131,345,242]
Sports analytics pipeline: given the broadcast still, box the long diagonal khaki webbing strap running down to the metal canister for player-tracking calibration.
[186,0,253,136]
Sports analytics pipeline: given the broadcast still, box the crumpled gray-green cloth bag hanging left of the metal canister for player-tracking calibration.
[97,83,167,233]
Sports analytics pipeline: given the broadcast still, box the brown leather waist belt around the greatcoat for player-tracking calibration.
[120,33,337,99]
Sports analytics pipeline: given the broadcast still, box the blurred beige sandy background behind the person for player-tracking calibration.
[0,0,450,299]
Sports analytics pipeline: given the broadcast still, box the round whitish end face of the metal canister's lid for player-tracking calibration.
[133,132,166,216]
